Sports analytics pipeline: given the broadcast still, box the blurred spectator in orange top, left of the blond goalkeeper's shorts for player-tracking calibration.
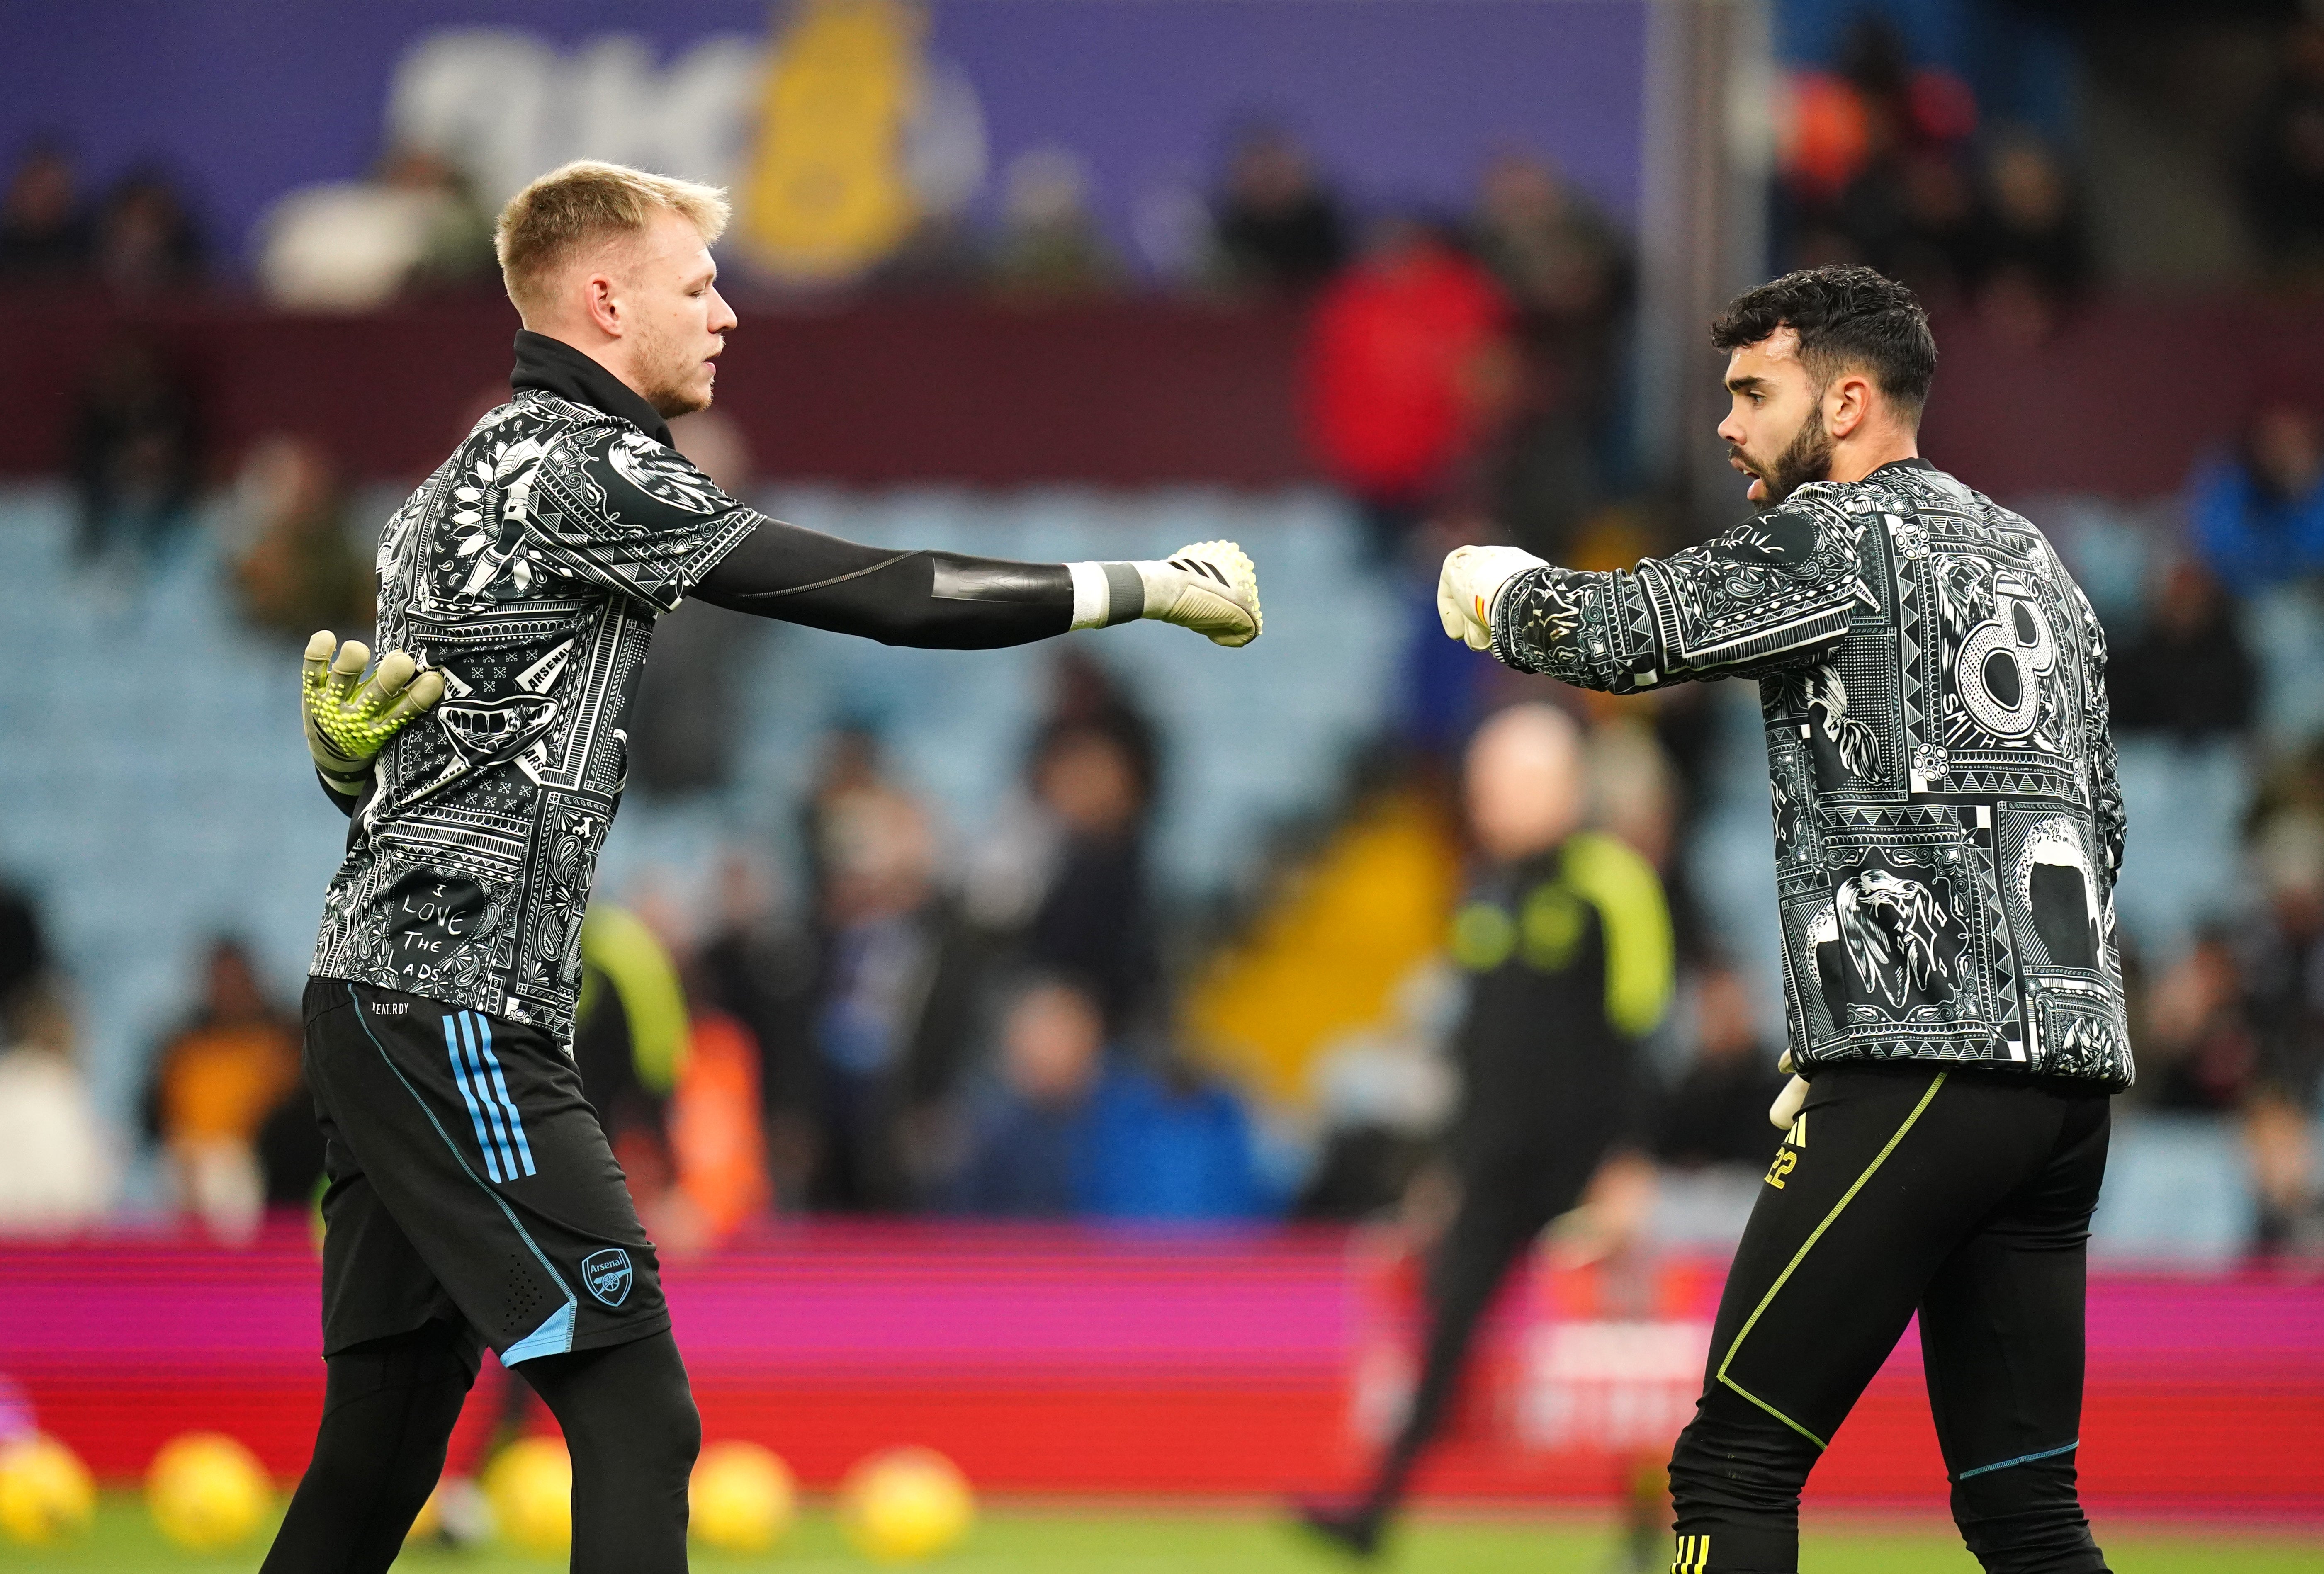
[146,939,300,1239]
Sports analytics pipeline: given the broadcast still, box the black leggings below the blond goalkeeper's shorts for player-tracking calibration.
[260,1323,702,1574]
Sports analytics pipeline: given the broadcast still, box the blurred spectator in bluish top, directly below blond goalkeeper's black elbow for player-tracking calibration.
[809,779,983,1209]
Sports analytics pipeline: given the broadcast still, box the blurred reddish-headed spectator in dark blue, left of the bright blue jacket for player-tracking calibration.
[951,981,1106,1218]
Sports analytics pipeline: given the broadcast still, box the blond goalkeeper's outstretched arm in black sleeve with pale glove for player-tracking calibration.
[693,518,1259,651]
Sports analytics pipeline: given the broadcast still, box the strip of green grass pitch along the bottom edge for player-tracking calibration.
[0,1495,2324,1574]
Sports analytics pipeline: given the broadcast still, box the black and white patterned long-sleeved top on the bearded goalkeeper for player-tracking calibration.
[1492,460,2133,1088]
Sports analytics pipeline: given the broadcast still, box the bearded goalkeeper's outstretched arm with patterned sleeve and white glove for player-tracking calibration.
[1436,486,1866,693]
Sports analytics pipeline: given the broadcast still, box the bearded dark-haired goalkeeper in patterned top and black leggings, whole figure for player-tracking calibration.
[1436,267,2133,1574]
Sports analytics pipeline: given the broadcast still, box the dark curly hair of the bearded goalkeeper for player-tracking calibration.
[1711,265,1936,416]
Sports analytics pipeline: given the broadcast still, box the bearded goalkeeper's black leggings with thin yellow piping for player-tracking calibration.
[1671,1067,2108,1574]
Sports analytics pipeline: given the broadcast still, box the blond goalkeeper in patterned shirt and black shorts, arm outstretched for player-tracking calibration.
[265,163,1259,1574]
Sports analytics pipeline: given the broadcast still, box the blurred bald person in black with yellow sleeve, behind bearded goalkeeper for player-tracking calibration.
[1301,702,1673,1558]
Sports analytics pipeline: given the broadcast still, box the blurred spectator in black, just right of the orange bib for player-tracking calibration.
[686,853,820,1207]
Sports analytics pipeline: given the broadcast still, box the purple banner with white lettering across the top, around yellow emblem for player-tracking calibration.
[0,0,1646,270]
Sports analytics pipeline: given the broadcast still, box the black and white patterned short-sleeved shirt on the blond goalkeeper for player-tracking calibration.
[311,391,762,1041]
